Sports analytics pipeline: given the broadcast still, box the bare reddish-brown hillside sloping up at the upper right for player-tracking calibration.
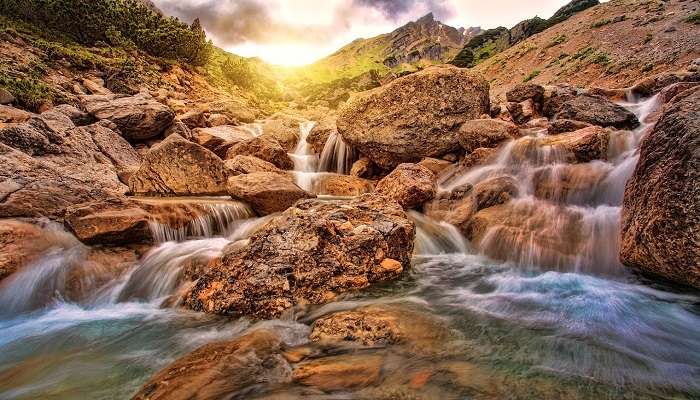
[473,0,700,98]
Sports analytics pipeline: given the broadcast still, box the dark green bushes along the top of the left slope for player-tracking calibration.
[0,0,212,65]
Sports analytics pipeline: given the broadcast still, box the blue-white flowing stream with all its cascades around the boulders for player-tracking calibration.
[0,98,700,399]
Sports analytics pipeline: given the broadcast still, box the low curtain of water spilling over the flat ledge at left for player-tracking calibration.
[150,201,255,243]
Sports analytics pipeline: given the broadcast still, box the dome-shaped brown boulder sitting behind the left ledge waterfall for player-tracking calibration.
[129,134,226,196]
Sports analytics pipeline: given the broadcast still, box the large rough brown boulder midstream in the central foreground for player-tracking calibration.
[185,194,415,318]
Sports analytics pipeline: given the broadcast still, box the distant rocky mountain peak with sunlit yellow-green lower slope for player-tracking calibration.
[290,13,481,83]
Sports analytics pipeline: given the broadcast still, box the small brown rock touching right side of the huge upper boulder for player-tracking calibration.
[459,119,519,154]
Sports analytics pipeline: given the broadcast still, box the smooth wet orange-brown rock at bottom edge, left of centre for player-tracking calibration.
[133,329,291,400]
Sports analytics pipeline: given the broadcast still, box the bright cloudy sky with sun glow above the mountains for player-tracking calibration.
[152,0,569,65]
